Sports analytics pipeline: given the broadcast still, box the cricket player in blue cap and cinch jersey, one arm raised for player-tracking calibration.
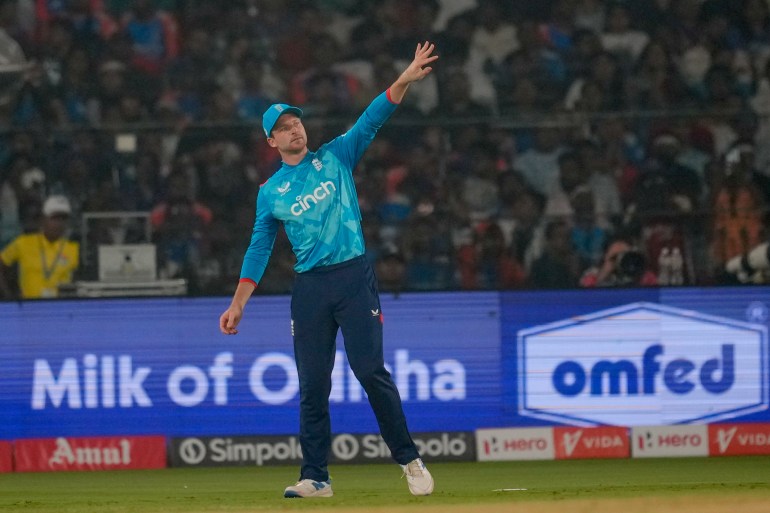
[219,41,438,497]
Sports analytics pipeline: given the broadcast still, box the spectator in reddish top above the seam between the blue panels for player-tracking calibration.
[457,223,526,290]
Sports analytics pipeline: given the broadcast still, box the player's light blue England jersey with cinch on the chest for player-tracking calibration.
[241,91,396,283]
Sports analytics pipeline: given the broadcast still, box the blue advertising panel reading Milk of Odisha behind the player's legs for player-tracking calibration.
[0,293,503,439]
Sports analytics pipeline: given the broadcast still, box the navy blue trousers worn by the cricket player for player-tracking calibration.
[291,256,419,481]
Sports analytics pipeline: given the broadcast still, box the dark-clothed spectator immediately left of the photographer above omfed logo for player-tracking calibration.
[529,220,580,289]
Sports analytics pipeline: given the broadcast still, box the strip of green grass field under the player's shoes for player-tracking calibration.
[0,456,770,513]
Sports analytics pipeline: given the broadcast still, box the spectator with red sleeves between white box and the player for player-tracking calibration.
[150,170,213,280]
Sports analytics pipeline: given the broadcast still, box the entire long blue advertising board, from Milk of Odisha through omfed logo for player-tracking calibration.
[0,287,770,439]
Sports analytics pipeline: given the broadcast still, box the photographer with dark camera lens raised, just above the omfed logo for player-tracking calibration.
[580,236,658,288]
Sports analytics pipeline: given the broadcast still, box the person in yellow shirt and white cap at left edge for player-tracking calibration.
[0,195,80,299]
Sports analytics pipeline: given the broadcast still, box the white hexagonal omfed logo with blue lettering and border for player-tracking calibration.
[518,303,768,426]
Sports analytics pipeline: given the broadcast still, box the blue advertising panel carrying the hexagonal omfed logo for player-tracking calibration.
[502,288,770,426]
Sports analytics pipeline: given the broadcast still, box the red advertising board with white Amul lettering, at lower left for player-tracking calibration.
[13,436,166,472]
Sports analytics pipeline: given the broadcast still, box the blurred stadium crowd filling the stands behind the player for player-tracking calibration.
[0,0,770,295]
